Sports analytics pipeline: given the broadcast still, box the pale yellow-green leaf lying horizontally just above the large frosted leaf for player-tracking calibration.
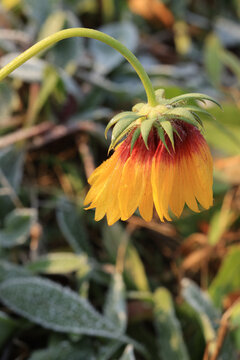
[26,252,91,278]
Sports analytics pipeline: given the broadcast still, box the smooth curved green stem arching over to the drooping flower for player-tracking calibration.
[0,28,157,106]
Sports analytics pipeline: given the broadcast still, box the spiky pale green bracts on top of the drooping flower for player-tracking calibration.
[105,89,221,151]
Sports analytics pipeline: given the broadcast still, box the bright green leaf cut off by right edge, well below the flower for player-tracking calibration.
[209,246,240,307]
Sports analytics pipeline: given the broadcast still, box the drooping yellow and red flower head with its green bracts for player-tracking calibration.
[85,91,219,225]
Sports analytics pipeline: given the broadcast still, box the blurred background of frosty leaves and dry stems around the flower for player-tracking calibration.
[0,0,240,360]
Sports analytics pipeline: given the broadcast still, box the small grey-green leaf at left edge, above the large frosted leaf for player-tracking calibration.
[0,209,36,248]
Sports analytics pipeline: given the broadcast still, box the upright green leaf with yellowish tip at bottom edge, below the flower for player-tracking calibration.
[153,287,189,360]
